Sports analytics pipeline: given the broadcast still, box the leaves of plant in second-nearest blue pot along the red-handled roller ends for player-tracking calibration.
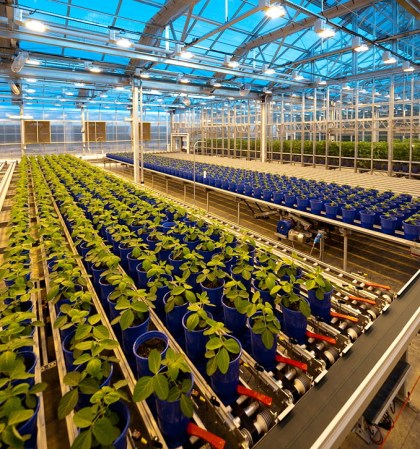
[204,319,241,376]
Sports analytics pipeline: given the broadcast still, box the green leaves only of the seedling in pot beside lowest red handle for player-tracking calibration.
[133,348,194,418]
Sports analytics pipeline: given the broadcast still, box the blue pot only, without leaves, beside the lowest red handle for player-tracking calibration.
[156,373,194,449]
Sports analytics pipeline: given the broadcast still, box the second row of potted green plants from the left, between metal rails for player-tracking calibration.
[31,159,130,449]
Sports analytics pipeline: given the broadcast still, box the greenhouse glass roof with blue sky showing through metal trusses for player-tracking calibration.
[0,0,420,112]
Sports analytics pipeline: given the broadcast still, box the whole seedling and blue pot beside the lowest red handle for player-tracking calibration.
[133,348,194,447]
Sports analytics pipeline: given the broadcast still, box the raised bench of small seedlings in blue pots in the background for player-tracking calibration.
[107,153,420,240]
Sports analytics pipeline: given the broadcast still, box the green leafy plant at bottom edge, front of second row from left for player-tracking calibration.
[65,380,129,449]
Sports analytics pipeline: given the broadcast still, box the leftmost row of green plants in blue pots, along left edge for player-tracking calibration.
[0,157,47,449]
